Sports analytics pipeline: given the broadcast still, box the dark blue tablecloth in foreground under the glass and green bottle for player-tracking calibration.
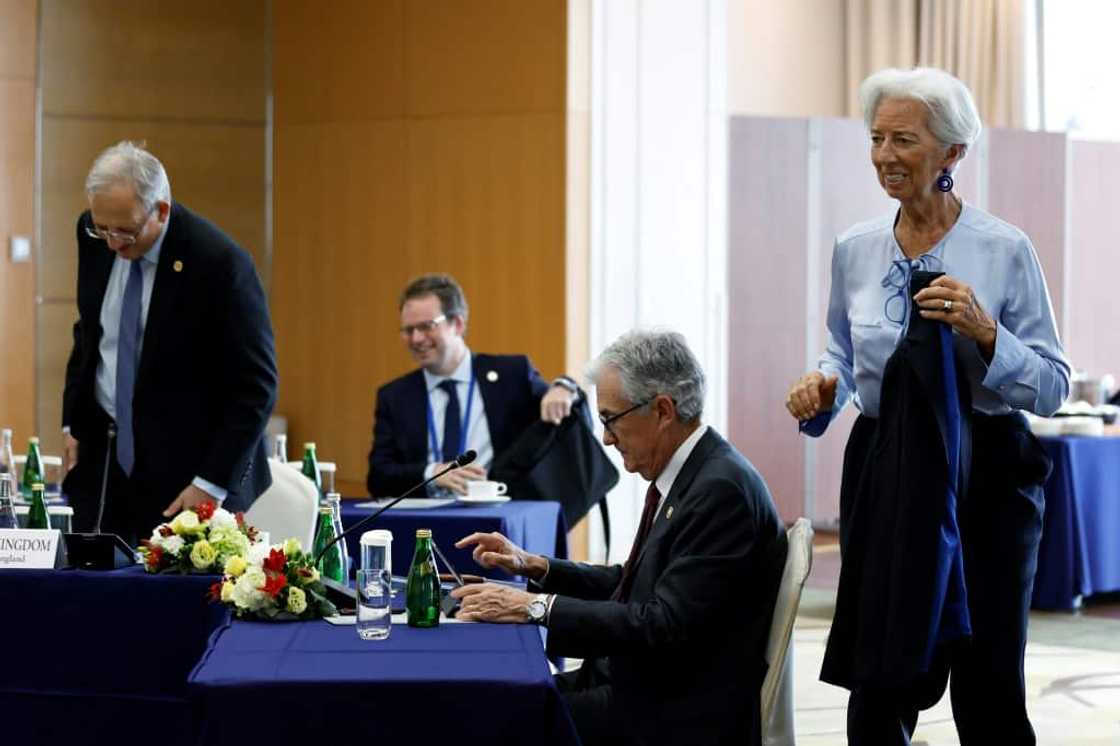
[190,622,578,746]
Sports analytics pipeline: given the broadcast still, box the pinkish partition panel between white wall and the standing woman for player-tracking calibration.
[727,118,810,520]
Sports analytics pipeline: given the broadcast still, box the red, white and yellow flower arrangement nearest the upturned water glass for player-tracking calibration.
[211,539,338,622]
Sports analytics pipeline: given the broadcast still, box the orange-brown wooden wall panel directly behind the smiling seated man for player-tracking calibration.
[271,0,566,494]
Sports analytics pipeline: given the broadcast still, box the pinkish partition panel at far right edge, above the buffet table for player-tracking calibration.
[1064,140,1120,375]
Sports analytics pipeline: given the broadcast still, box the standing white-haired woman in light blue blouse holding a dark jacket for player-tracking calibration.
[785,68,1070,746]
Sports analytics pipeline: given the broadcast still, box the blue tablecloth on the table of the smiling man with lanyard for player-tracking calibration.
[343,500,568,579]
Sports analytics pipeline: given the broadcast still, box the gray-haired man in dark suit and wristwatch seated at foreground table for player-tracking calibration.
[452,332,786,746]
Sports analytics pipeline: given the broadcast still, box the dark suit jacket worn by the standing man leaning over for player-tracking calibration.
[63,203,278,529]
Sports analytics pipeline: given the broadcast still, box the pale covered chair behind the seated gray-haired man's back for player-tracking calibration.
[760,517,813,746]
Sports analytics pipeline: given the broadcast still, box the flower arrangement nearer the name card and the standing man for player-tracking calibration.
[140,501,258,575]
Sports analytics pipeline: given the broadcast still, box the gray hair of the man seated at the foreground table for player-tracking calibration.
[587,330,706,422]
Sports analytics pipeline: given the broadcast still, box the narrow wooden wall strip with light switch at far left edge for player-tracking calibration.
[0,0,37,448]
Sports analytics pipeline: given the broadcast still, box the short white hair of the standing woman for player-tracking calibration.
[859,67,983,158]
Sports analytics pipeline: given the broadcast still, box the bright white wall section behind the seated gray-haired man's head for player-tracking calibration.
[589,0,727,561]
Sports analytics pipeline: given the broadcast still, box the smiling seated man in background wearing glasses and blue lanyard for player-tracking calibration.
[366,274,578,497]
